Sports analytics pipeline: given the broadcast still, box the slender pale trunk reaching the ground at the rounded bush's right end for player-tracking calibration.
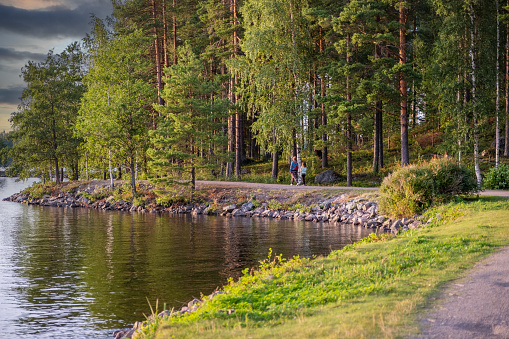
[469,2,482,189]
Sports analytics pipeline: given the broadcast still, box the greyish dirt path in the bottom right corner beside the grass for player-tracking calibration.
[418,247,509,338]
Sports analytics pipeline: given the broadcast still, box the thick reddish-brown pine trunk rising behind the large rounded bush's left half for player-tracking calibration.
[399,0,410,166]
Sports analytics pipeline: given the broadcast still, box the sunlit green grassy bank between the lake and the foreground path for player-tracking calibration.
[138,197,509,338]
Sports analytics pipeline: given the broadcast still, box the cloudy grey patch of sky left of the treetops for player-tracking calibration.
[0,0,113,132]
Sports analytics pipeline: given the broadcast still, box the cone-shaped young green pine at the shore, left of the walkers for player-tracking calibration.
[148,44,226,189]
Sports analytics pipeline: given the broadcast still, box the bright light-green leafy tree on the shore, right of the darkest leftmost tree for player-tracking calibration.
[75,26,154,195]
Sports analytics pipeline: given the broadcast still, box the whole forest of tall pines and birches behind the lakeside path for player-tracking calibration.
[3,0,509,194]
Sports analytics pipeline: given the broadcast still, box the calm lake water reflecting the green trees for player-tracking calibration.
[0,178,369,338]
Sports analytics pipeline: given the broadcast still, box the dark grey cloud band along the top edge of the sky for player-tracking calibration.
[0,3,107,38]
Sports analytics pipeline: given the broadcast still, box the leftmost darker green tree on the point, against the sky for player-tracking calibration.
[10,43,85,181]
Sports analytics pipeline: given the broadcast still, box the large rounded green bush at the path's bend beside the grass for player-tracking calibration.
[380,158,477,217]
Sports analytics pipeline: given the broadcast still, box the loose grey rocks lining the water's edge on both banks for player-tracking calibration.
[4,185,424,339]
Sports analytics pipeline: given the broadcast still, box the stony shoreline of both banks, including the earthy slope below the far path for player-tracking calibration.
[3,182,425,339]
